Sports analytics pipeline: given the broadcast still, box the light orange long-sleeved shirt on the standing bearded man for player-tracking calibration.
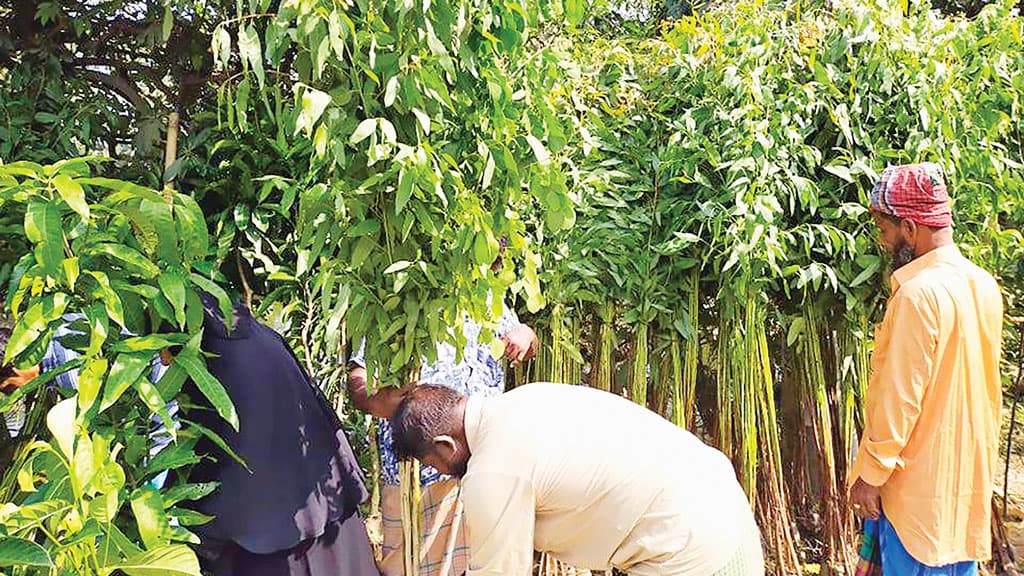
[850,246,1002,566]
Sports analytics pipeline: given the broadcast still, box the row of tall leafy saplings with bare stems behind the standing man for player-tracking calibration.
[516,2,1024,571]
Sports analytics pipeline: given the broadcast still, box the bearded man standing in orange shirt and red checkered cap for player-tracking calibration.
[850,164,1002,576]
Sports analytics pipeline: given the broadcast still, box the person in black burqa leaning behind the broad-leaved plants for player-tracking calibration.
[188,298,379,576]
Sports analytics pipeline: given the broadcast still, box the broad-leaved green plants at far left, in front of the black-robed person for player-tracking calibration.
[0,158,239,575]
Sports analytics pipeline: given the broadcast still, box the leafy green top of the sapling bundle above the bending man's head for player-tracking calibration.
[214,1,573,383]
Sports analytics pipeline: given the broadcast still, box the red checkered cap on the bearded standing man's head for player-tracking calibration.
[871,162,953,228]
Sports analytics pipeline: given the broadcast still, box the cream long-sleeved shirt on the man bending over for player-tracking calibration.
[463,383,757,576]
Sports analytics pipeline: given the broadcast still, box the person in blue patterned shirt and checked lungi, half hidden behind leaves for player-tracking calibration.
[348,293,537,576]
